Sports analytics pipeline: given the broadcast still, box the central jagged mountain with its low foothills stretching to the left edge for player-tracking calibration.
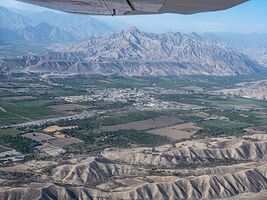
[0,28,261,76]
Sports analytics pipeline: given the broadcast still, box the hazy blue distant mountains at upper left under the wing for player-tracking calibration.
[0,7,115,44]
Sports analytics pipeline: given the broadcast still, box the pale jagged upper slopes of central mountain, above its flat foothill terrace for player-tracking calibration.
[56,28,262,75]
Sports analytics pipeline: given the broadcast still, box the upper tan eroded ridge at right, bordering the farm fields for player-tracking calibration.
[102,136,267,168]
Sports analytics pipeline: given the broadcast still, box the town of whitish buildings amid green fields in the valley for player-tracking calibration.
[57,87,203,110]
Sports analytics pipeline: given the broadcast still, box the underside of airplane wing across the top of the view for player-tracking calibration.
[18,0,248,15]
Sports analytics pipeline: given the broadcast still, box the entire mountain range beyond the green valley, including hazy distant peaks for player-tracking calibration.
[0,7,267,76]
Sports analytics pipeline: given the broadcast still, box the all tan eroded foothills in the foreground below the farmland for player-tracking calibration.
[0,134,267,199]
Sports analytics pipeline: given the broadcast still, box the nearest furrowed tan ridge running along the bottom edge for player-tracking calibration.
[0,165,267,199]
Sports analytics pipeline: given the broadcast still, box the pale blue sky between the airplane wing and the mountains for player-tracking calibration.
[0,0,267,33]
